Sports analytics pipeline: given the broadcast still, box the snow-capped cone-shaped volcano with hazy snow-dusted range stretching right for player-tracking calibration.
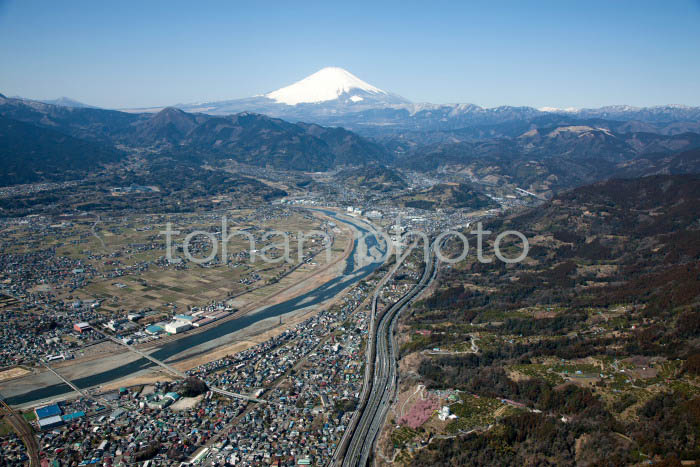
[161,67,700,137]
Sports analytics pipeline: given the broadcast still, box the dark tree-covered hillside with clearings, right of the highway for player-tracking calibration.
[401,175,700,465]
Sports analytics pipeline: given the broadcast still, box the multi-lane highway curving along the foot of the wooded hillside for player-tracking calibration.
[336,243,437,467]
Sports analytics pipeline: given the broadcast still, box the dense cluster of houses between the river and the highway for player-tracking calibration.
[24,274,378,465]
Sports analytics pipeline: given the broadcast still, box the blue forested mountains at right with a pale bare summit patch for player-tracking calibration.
[394,125,700,196]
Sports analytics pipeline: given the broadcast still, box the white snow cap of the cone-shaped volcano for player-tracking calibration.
[265,67,388,105]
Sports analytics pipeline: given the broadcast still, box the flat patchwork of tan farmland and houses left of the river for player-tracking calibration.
[0,207,336,315]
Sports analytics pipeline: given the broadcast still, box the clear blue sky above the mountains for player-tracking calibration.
[0,0,700,108]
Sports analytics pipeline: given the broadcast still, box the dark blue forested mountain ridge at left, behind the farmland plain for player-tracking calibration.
[0,93,391,183]
